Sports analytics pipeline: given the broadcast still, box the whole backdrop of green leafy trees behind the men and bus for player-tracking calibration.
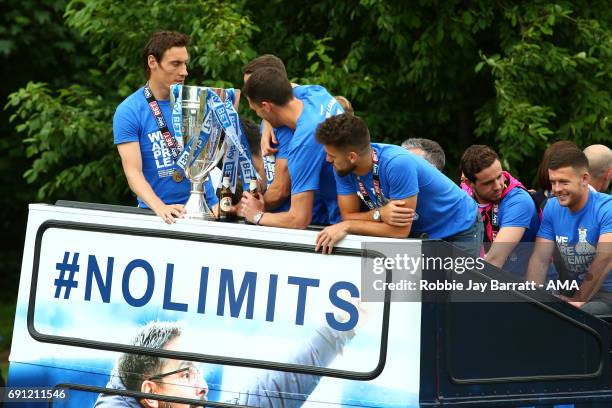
[0,0,612,380]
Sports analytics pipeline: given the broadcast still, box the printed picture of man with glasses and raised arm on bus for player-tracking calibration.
[94,322,355,408]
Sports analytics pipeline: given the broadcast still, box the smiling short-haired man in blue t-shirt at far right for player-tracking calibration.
[527,146,612,315]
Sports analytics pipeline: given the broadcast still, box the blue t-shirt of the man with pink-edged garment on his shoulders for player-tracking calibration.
[499,187,540,276]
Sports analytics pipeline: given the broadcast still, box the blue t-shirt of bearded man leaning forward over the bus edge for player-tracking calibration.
[334,143,478,238]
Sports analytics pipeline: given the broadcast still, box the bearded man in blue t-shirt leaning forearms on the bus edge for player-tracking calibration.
[316,114,482,257]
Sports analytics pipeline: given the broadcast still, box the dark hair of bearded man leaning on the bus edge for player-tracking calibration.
[316,113,370,153]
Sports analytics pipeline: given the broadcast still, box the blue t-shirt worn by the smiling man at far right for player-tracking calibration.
[538,190,612,291]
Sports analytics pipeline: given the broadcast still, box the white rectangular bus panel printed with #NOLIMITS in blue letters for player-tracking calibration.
[34,229,383,373]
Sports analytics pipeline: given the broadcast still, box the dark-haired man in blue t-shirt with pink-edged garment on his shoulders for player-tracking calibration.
[460,145,540,277]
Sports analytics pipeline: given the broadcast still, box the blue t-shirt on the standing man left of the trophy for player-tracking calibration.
[113,88,219,208]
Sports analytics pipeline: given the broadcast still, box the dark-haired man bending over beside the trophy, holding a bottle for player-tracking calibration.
[242,68,342,229]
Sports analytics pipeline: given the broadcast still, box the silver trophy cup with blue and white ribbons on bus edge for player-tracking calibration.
[172,85,225,220]
